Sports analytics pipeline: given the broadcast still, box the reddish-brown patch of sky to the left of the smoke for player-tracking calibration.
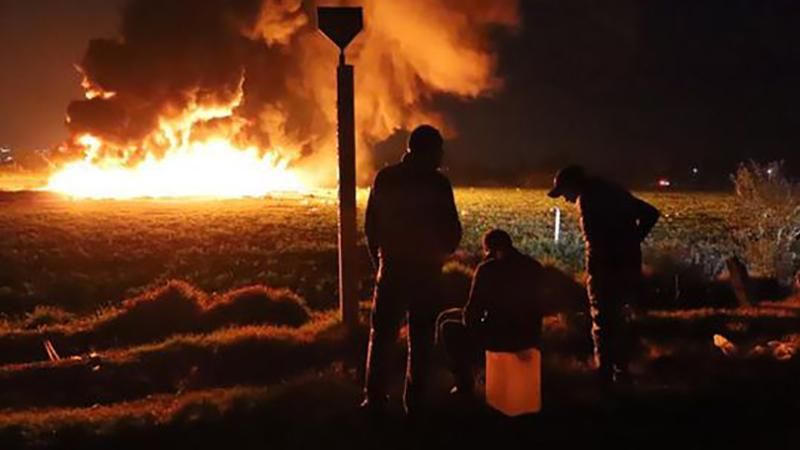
[0,0,124,149]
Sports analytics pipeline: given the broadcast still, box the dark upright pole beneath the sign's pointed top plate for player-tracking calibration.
[337,52,358,327]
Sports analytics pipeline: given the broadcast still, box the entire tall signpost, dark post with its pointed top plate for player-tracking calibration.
[317,7,364,327]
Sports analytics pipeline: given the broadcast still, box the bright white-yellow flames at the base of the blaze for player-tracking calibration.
[46,89,307,199]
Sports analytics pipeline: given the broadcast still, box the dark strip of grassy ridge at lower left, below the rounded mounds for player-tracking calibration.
[0,314,349,408]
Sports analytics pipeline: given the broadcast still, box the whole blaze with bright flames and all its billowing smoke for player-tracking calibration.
[47,0,518,198]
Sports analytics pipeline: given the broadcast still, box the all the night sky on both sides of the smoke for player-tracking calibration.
[0,0,800,184]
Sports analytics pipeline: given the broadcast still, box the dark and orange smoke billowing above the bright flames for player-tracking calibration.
[65,0,518,182]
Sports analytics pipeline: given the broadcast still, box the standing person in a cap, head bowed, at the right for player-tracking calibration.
[548,165,660,386]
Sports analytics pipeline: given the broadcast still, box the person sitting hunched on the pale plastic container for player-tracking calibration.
[437,230,544,396]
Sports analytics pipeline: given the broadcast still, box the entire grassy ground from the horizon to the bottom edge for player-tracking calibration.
[0,189,800,450]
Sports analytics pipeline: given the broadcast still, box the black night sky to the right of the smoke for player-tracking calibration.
[440,0,800,184]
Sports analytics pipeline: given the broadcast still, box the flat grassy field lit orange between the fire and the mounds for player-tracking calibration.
[0,189,733,314]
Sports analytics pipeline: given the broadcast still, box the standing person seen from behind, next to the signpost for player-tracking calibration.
[362,125,462,413]
